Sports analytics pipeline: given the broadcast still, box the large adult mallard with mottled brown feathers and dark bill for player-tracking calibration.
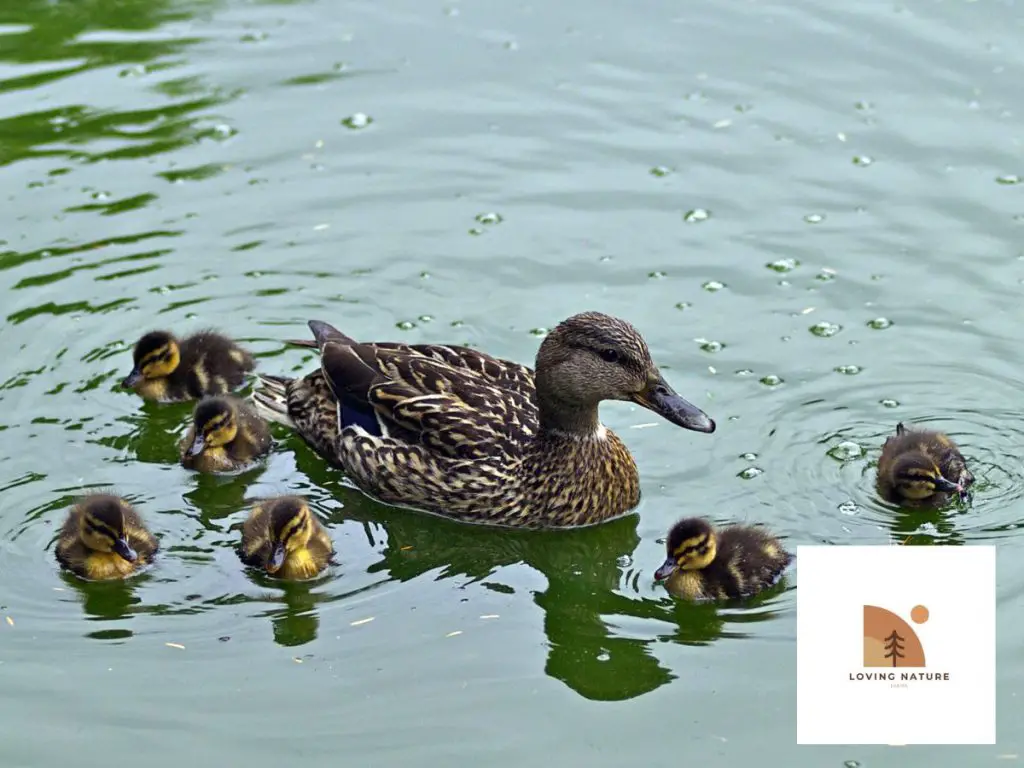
[254,312,715,528]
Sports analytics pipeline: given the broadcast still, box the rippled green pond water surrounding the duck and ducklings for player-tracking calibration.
[0,0,1024,768]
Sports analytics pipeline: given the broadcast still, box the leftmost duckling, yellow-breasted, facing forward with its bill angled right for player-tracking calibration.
[56,494,160,581]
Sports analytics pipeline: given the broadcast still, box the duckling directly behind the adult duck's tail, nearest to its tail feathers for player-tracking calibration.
[179,395,272,472]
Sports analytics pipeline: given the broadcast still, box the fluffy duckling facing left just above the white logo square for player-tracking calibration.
[654,517,793,600]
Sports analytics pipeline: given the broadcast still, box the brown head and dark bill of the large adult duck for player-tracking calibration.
[536,312,715,432]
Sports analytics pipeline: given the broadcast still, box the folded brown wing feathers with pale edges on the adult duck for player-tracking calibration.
[321,342,537,459]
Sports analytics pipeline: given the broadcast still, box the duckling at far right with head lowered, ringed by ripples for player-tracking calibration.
[876,422,974,507]
